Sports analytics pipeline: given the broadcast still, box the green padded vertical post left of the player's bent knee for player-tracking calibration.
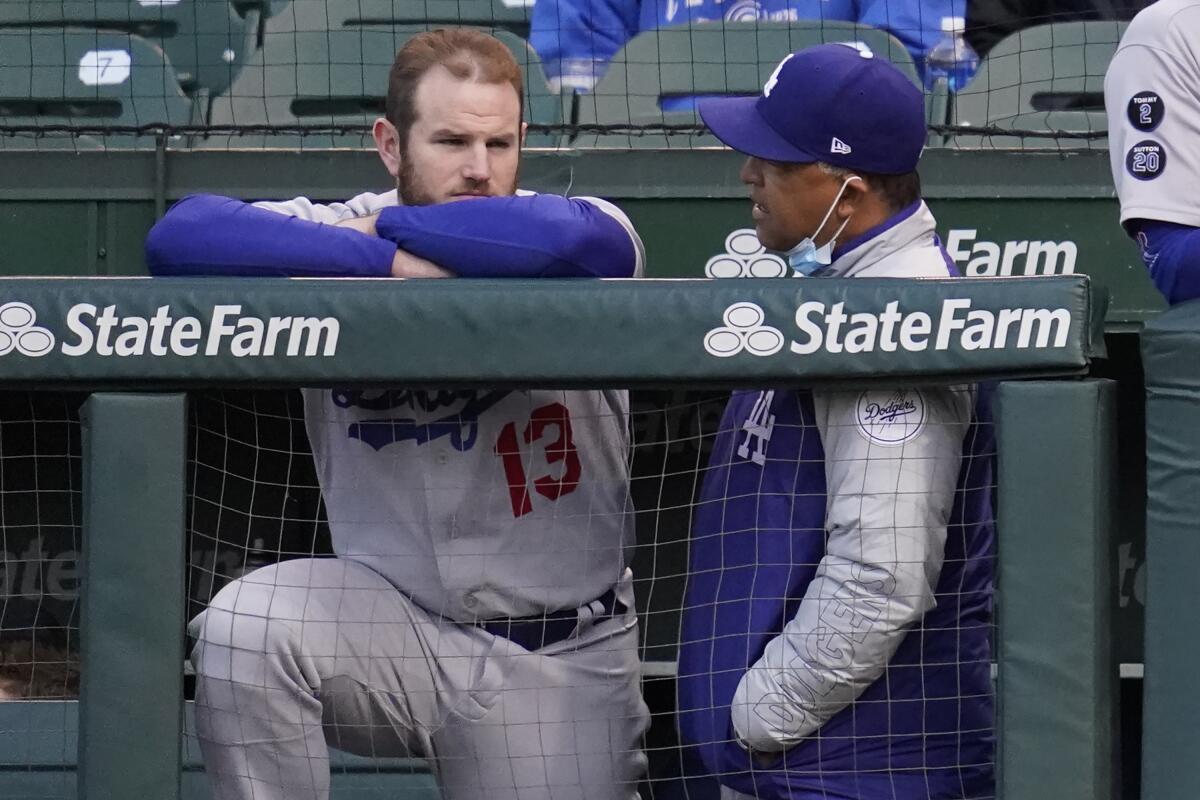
[78,395,187,800]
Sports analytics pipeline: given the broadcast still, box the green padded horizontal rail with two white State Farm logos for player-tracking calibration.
[0,276,1104,387]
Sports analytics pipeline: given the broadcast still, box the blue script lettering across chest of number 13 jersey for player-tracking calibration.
[332,390,510,452]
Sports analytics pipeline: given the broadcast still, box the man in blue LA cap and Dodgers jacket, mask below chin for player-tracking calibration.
[678,44,994,800]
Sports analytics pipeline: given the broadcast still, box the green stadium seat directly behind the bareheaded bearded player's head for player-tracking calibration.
[198,6,566,149]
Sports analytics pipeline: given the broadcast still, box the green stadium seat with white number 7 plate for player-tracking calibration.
[0,28,194,149]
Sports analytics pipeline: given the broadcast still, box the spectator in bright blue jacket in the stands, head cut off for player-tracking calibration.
[529,0,966,91]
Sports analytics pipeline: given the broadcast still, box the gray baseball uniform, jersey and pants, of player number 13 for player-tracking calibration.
[184,192,649,800]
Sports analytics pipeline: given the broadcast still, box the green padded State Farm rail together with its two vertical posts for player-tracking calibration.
[0,277,1117,800]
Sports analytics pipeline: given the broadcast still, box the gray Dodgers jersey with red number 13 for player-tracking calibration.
[258,191,644,621]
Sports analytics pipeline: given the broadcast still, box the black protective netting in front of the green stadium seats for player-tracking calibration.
[0,0,1147,150]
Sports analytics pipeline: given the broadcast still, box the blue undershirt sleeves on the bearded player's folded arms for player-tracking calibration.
[145,194,637,277]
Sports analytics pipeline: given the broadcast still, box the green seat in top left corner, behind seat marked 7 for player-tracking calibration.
[0,0,264,94]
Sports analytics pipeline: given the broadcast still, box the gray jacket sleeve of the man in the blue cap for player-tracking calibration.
[732,386,976,752]
